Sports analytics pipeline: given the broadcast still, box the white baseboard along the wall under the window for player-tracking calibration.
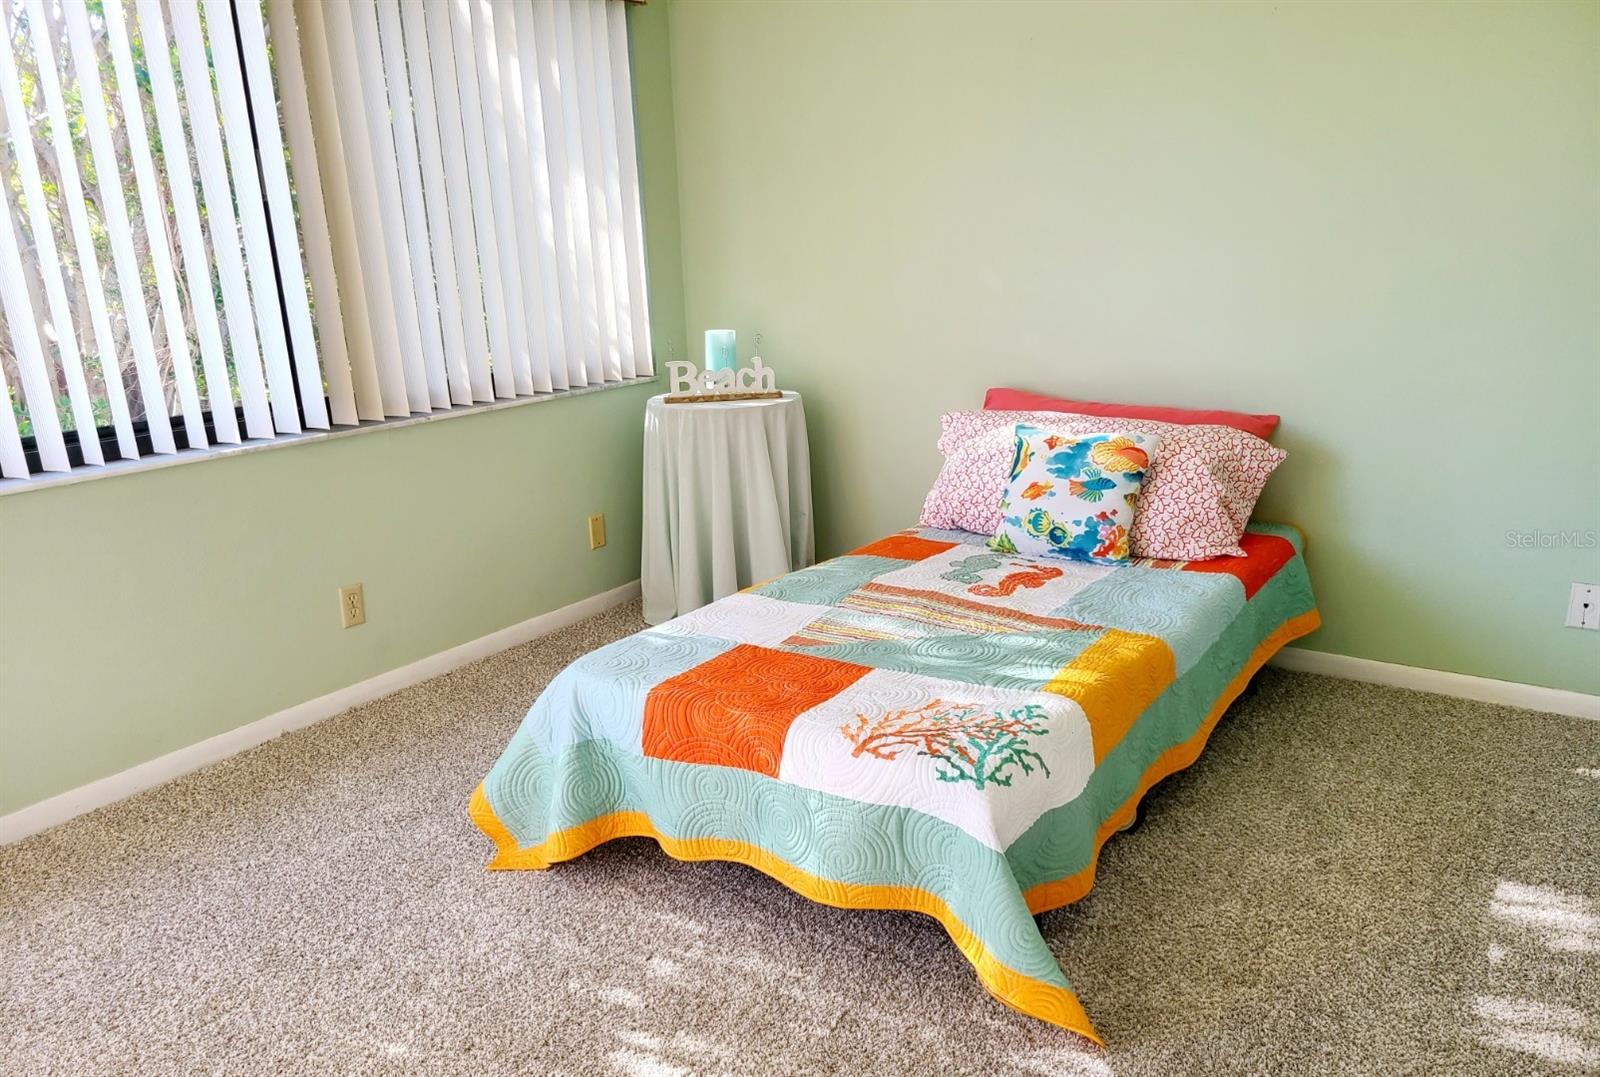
[0,579,638,845]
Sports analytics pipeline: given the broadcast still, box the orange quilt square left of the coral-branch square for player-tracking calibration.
[643,643,867,778]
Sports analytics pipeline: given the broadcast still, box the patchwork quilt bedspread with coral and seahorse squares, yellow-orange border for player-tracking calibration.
[470,525,1317,1040]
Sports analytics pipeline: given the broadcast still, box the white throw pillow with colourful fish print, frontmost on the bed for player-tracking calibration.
[989,424,1162,565]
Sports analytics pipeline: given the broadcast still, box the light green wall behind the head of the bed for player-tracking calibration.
[670,0,1600,691]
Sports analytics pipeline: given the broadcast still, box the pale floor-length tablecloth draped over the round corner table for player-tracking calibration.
[640,392,816,624]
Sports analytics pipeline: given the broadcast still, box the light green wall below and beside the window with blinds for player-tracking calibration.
[0,6,683,815]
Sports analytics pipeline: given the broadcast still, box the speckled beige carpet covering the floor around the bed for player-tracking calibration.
[0,605,1600,1075]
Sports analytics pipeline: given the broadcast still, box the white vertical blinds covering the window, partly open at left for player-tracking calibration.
[0,0,653,478]
